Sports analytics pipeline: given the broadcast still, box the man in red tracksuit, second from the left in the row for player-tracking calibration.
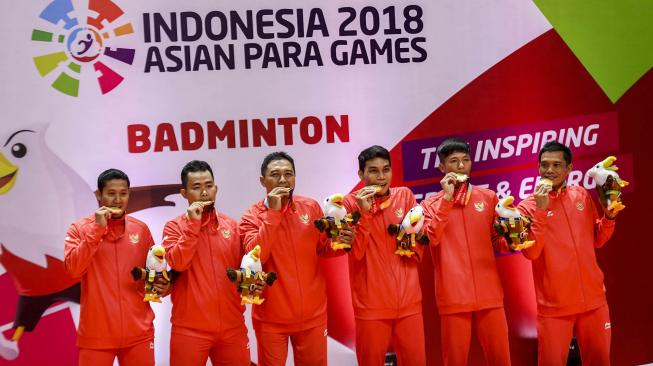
[163,160,250,366]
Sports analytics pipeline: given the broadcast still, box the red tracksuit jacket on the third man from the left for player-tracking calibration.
[240,195,344,333]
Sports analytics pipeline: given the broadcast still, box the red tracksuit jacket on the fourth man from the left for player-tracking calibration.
[344,187,423,320]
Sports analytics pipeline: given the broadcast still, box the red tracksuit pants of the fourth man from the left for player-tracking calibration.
[356,313,426,366]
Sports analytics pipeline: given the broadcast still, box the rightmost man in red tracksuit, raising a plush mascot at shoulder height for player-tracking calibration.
[519,142,617,365]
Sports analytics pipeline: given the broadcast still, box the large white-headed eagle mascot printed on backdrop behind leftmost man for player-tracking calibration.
[0,124,179,360]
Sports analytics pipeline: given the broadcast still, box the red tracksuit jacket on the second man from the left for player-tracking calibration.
[163,212,245,336]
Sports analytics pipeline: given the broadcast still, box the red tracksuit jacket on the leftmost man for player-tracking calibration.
[64,215,154,349]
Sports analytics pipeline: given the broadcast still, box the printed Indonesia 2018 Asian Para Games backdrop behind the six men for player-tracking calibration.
[0,0,653,366]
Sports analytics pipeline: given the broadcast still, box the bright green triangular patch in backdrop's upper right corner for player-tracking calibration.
[534,0,653,103]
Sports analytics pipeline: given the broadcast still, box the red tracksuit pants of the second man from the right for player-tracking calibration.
[440,307,510,366]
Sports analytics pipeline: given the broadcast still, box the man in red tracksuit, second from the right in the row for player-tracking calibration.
[422,139,510,365]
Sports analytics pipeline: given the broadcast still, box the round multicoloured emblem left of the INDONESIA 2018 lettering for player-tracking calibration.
[32,0,136,97]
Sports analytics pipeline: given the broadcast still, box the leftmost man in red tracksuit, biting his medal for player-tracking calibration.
[64,169,168,366]
